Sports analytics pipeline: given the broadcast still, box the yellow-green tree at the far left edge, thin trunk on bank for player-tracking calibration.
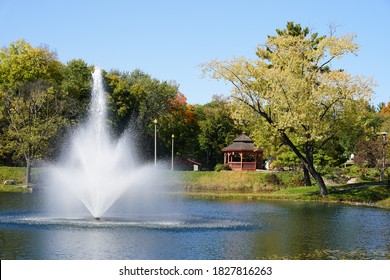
[0,40,64,184]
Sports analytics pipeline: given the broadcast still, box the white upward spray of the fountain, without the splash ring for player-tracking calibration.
[48,68,155,219]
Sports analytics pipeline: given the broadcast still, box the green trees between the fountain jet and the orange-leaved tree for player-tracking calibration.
[106,70,183,160]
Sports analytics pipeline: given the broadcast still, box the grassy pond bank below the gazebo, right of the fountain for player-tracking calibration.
[174,172,390,208]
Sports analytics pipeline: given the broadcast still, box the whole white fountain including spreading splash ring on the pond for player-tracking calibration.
[37,68,253,230]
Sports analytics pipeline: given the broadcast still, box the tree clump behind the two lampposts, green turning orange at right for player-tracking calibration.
[106,70,199,160]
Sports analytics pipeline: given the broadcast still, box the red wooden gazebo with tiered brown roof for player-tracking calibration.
[222,133,263,171]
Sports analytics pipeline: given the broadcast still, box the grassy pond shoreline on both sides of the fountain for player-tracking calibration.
[0,167,390,209]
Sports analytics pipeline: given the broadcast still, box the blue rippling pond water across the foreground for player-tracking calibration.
[0,192,390,260]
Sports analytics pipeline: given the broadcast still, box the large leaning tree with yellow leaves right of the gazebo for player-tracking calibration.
[204,23,373,195]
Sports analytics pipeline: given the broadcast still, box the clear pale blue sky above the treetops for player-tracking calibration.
[0,0,390,105]
